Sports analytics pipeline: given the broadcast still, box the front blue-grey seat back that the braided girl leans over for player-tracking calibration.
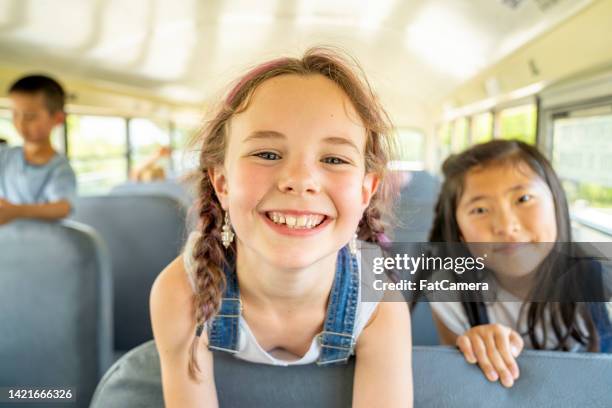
[91,341,612,408]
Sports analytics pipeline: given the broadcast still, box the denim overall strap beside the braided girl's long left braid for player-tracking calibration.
[208,255,242,353]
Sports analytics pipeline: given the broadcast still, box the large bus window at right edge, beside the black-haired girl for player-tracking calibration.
[552,107,612,236]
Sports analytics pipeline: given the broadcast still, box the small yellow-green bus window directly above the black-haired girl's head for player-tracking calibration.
[498,104,537,145]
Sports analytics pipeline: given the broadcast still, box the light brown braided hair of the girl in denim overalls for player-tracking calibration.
[189,48,404,379]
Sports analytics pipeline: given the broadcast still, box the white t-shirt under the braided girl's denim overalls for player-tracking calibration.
[183,232,379,366]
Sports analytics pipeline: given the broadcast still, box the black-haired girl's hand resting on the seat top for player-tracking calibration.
[456,324,524,387]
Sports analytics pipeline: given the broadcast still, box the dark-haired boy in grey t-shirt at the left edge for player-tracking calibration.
[0,75,76,225]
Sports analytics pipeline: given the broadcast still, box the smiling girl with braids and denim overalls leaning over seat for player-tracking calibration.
[151,49,412,407]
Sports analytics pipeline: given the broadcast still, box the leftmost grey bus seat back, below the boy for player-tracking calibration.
[0,221,112,407]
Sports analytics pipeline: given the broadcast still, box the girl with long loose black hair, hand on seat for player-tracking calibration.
[430,140,612,387]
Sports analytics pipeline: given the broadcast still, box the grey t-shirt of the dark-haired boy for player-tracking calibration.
[0,146,76,206]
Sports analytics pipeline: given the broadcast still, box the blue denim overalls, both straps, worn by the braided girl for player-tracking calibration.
[208,247,360,365]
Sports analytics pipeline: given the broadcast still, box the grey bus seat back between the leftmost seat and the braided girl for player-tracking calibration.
[72,195,186,351]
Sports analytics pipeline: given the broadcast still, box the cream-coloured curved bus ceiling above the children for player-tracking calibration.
[0,0,612,128]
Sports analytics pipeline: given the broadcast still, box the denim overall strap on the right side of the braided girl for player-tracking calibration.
[317,247,360,365]
